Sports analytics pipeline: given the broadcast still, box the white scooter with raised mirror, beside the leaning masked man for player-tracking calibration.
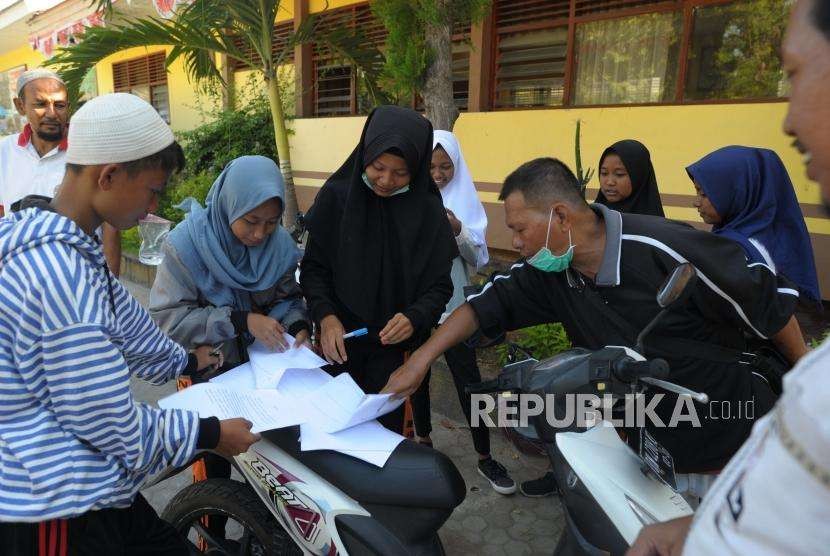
[467,264,708,555]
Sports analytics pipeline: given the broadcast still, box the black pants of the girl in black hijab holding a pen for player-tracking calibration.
[323,337,404,434]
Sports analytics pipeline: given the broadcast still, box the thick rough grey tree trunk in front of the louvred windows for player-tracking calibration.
[423,0,458,131]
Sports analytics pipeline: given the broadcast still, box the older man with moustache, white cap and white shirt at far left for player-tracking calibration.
[0,68,121,276]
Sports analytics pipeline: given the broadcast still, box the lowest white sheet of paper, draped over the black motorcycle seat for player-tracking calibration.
[300,421,404,467]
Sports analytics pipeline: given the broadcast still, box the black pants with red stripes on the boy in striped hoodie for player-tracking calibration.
[0,494,190,556]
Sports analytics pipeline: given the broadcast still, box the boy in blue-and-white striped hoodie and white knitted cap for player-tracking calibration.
[0,93,258,556]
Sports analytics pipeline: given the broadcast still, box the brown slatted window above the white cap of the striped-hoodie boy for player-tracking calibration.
[112,52,170,123]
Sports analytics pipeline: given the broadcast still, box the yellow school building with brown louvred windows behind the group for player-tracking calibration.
[0,0,830,298]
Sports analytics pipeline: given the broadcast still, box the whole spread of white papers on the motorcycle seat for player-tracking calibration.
[159,334,404,467]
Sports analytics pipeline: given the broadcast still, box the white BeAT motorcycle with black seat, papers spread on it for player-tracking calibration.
[156,427,466,556]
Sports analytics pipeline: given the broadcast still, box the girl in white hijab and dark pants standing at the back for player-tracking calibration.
[412,130,516,494]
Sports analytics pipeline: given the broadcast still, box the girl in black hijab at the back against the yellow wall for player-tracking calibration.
[595,139,665,216]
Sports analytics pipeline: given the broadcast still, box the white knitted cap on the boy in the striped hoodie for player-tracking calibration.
[66,93,175,166]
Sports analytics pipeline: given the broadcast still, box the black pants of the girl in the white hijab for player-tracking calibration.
[411,342,490,456]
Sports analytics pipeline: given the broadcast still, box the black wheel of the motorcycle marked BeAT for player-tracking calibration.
[161,479,303,556]
